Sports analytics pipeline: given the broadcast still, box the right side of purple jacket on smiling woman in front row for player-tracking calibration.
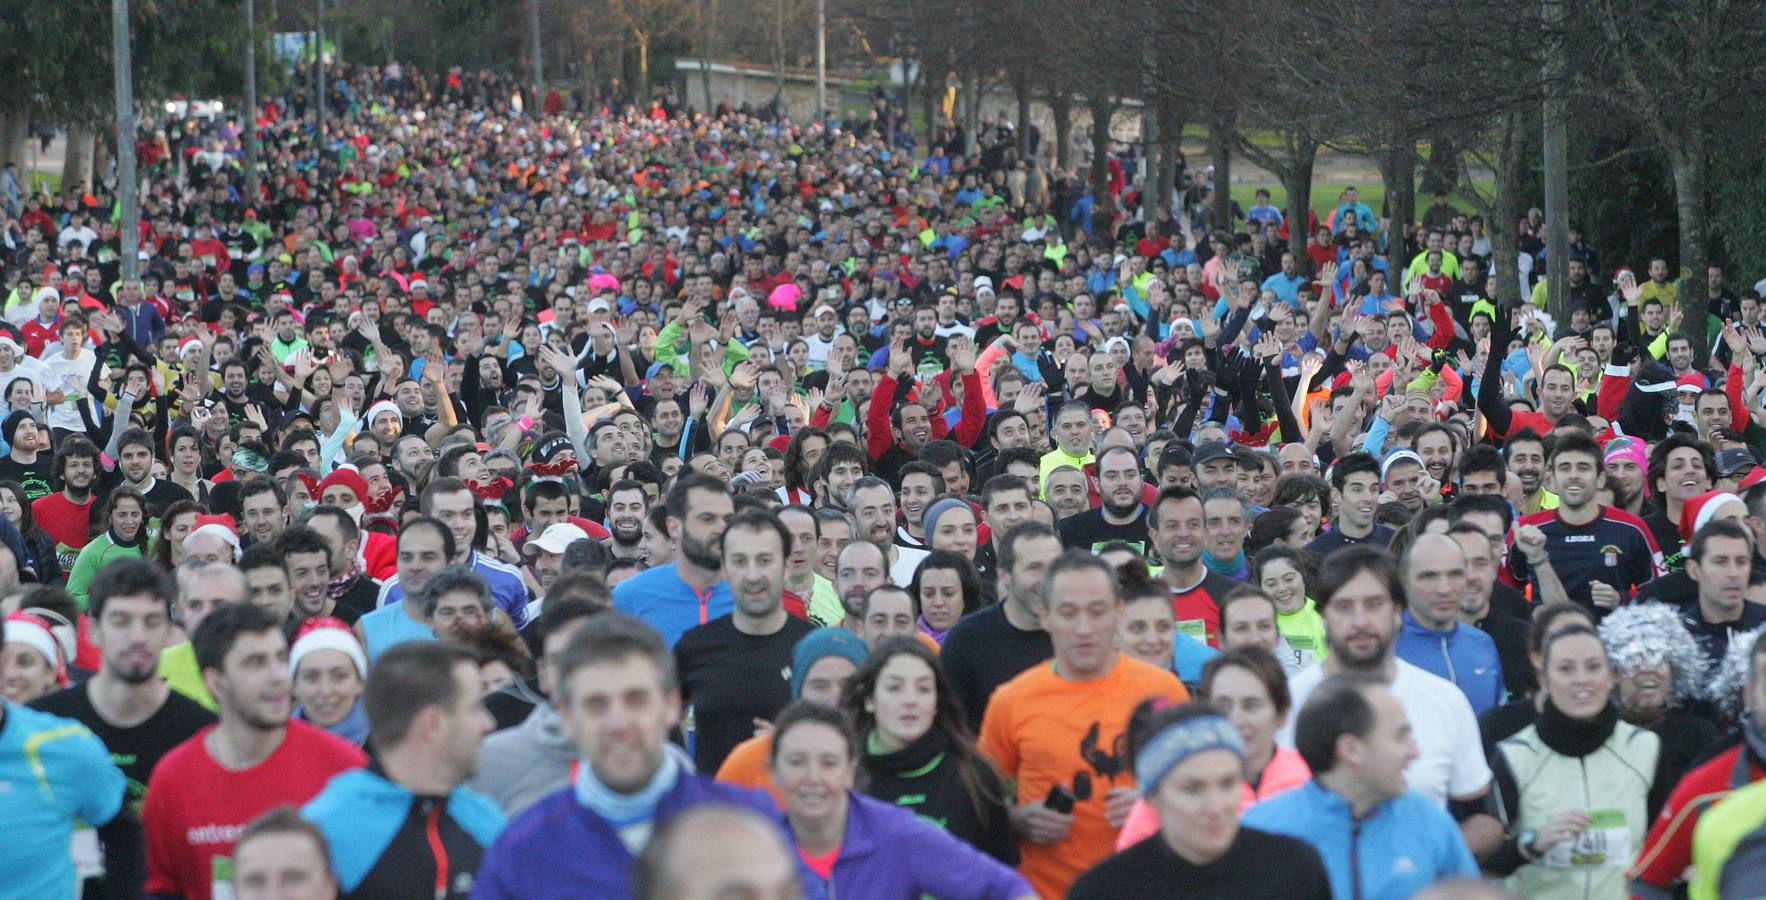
[808,791,1033,900]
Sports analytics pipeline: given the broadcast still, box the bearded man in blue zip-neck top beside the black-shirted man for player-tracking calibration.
[613,471,735,648]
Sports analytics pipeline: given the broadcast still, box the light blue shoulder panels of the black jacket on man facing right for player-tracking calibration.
[300,769,503,893]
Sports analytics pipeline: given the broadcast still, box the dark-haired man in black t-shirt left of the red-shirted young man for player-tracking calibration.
[32,559,215,889]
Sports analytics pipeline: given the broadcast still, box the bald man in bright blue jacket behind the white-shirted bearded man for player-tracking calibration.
[1395,535,1506,715]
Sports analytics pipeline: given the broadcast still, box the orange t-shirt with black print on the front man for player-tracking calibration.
[980,655,1190,896]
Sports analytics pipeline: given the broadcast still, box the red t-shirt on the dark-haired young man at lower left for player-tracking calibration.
[141,720,367,900]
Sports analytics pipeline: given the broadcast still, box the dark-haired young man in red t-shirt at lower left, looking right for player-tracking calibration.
[141,604,367,900]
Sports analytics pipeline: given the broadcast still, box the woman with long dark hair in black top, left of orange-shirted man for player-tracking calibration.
[841,637,1017,866]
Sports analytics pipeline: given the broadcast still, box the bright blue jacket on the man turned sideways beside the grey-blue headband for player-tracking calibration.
[1243,778,1478,900]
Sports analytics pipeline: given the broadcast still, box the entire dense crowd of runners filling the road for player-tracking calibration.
[0,64,1766,900]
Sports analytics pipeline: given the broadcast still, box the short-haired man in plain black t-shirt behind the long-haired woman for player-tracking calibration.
[675,510,814,771]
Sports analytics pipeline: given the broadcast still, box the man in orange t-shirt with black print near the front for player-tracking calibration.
[980,551,1189,896]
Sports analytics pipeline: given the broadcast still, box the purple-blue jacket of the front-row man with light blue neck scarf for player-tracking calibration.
[472,773,821,900]
